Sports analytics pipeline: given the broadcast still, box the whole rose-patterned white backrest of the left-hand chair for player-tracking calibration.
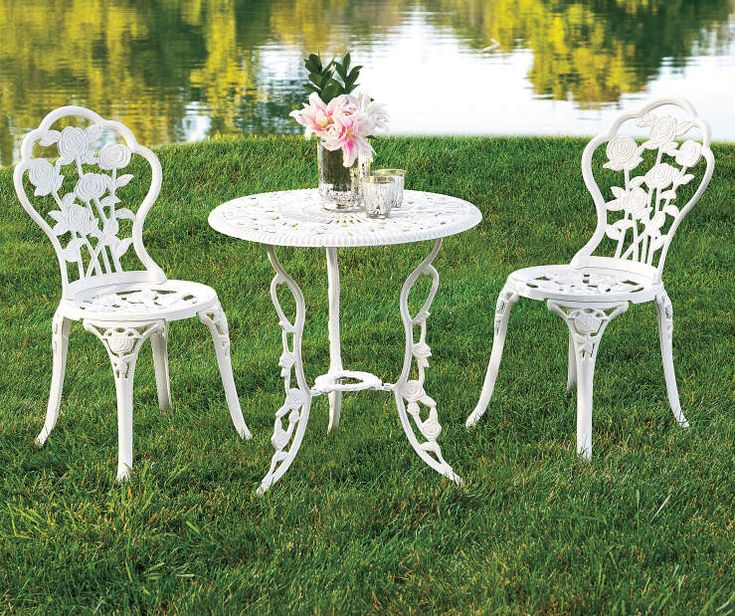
[13,106,166,297]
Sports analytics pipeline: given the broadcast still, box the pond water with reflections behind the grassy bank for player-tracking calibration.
[0,0,735,165]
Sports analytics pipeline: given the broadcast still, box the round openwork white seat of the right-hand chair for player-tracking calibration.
[508,265,661,303]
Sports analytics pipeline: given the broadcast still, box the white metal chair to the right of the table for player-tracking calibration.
[467,99,714,459]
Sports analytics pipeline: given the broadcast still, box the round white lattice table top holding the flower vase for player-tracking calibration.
[209,188,482,248]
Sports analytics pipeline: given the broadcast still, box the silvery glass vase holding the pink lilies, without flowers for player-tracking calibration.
[317,143,370,211]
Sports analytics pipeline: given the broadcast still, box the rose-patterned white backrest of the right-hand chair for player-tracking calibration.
[572,99,714,280]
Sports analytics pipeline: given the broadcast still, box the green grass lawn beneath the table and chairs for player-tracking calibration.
[0,137,735,614]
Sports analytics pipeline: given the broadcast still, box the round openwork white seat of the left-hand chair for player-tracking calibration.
[61,280,217,321]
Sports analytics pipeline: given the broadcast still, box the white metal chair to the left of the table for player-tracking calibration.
[14,106,251,481]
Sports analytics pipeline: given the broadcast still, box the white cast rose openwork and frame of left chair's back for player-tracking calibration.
[13,108,160,285]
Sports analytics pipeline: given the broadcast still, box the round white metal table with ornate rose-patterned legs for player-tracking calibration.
[209,189,482,494]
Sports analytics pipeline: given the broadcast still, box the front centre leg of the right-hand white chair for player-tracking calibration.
[547,301,628,460]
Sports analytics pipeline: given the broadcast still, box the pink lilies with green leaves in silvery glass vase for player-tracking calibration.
[290,53,388,209]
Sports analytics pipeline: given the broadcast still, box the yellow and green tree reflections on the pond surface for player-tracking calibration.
[0,0,732,165]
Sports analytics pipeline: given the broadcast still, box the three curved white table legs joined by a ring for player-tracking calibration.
[258,239,462,494]
